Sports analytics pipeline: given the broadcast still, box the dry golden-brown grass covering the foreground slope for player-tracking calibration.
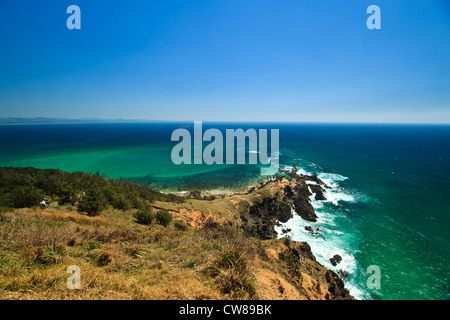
[0,205,264,299]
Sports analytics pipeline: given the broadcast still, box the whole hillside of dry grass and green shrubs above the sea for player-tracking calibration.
[0,168,348,299]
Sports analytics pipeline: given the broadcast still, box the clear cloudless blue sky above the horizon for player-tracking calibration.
[0,0,450,123]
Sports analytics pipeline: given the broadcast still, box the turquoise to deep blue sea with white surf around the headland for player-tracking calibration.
[0,122,450,299]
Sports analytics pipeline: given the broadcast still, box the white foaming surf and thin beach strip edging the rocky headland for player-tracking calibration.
[185,165,369,299]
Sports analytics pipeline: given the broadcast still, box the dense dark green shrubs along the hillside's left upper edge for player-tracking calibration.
[0,168,182,216]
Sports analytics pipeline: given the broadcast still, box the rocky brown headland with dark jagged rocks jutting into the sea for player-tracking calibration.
[156,167,354,299]
